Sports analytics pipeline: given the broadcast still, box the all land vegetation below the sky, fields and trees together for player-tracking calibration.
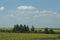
[0,24,60,40]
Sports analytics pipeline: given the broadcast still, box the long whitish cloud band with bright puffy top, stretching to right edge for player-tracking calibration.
[9,6,60,18]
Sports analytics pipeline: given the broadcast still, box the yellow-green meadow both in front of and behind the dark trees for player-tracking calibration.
[0,28,60,40]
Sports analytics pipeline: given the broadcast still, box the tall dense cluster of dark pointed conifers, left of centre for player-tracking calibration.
[13,24,29,33]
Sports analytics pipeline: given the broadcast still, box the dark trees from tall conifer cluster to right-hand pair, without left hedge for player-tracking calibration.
[13,24,54,34]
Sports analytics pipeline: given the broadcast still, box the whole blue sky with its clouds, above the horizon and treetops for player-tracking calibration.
[0,0,60,28]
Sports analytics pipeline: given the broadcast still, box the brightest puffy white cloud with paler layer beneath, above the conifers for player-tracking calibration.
[8,6,40,16]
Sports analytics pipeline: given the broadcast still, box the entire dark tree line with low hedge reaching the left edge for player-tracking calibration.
[0,24,60,34]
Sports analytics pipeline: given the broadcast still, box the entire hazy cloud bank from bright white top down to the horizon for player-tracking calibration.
[0,6,60,27]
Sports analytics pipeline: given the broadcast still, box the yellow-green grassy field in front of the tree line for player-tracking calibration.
[0,33,60,40]
